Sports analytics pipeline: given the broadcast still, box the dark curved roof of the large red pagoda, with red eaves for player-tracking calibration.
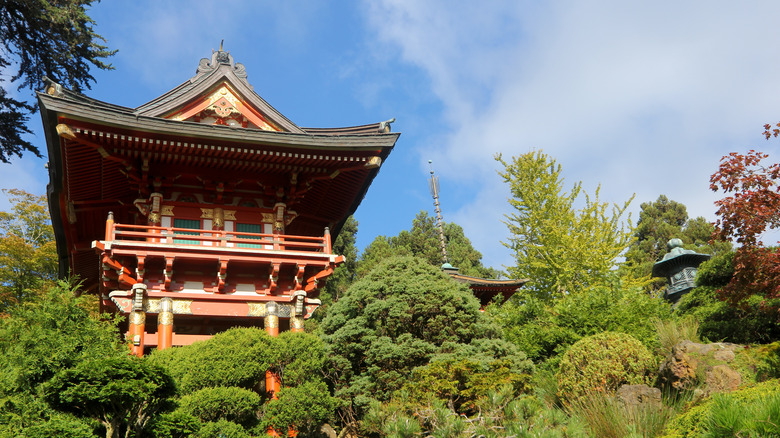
[38,48,400,284]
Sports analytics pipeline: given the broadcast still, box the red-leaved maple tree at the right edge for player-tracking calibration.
[710,123,780,310]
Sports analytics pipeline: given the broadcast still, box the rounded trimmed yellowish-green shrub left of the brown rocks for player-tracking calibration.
[557,332,655,401]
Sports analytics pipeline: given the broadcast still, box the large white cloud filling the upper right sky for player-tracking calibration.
[369,0,780,264]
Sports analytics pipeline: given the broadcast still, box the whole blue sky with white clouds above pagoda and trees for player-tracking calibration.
[0,0,780,267]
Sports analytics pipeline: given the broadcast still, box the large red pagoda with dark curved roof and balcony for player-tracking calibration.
[38,47,400,355]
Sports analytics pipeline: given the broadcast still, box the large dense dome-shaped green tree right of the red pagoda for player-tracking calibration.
[321,256,530,427]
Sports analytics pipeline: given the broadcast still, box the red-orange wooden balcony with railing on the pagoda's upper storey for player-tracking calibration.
[92,217,344,294]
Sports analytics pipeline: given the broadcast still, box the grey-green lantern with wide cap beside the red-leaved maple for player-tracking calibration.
[653,239,712,303]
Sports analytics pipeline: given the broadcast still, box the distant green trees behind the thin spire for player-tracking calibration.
[358,210,499,278]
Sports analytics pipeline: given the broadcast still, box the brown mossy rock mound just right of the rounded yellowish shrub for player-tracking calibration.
[658,341,745,394]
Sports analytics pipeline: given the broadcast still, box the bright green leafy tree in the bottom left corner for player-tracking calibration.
[0,283,127,436]
